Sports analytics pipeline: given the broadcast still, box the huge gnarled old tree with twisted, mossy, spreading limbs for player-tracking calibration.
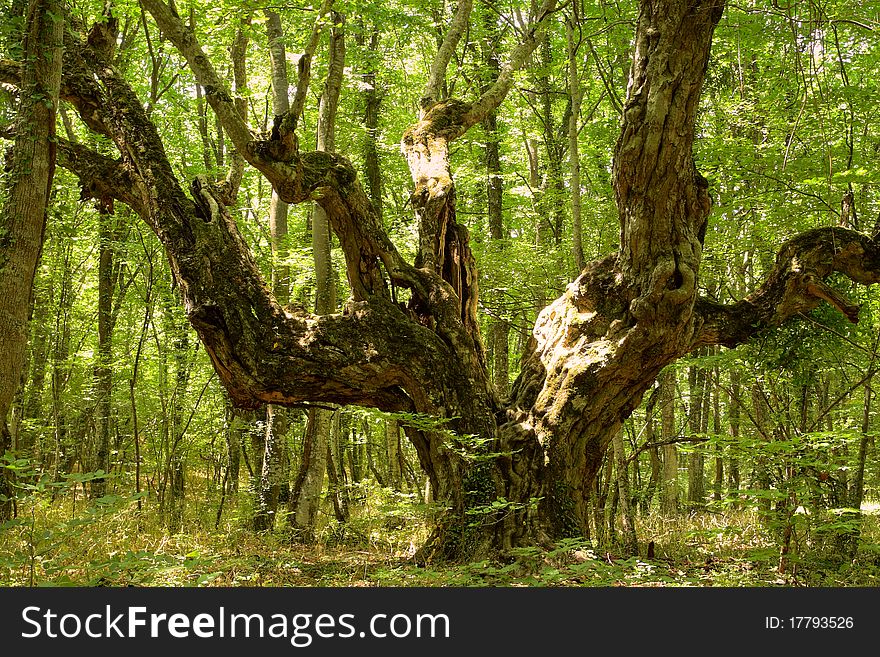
[10,0,880,558]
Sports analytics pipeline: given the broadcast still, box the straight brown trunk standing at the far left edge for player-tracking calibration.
[0,0,64,522]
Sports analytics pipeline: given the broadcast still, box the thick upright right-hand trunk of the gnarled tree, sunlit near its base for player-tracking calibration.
[498,2,722,534]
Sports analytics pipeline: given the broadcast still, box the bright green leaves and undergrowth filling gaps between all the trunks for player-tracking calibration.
[0,0,880,586]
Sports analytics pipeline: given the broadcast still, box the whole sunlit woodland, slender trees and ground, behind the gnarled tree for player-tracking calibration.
[0,0,880,586]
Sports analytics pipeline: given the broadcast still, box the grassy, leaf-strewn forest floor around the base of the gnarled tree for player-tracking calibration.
[0,496,880,587]
